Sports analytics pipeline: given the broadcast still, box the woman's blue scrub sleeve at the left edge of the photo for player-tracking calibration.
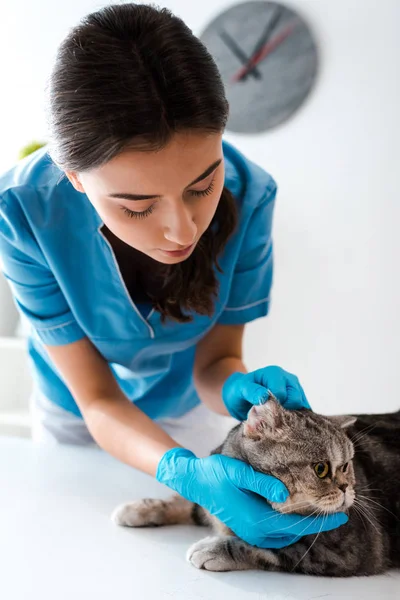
[0,197,85,345]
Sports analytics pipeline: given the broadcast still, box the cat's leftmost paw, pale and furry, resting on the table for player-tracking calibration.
[111,498,165,527]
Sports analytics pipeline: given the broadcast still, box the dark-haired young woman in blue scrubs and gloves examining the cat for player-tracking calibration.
[0,4,347,547]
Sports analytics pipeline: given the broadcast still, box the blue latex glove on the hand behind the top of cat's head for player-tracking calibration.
[222,367,311,421]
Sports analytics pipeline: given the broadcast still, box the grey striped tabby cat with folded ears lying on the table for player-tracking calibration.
[112,397,400,577]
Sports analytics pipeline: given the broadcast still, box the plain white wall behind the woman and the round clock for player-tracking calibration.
[0,0,400,413]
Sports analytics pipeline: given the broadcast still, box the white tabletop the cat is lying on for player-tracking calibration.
[0,437,400,600]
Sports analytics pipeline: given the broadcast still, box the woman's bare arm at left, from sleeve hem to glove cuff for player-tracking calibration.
[46,337,179,475]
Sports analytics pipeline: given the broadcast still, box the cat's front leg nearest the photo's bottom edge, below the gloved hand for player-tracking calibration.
[186,536,283,571]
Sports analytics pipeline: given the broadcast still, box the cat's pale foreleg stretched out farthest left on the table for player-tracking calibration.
[111,494,208,527]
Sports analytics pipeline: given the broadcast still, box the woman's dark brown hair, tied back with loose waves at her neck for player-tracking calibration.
[46,3,237,322]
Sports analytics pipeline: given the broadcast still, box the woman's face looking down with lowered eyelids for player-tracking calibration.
[66,132,225,264]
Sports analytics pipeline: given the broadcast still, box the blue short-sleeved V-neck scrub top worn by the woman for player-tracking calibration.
[0,140,276,419]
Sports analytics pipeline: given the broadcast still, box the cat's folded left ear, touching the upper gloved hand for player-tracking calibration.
[243,396,285,440]
